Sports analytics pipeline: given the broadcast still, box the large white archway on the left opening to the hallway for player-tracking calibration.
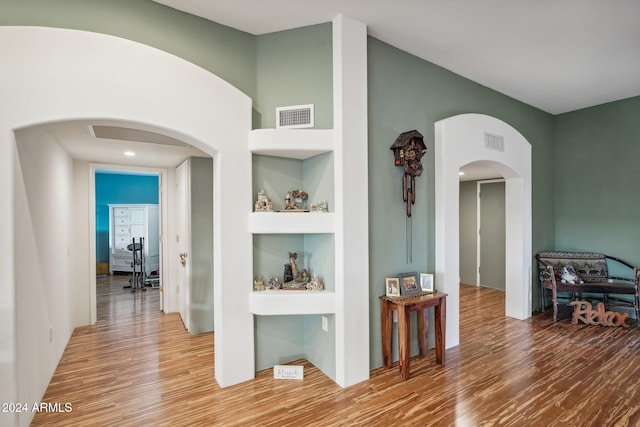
[0,27,254,418]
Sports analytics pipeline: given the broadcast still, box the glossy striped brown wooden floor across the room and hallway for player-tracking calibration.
[32,282,640,427]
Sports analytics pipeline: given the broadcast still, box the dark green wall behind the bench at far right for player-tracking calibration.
[549,97,640,265]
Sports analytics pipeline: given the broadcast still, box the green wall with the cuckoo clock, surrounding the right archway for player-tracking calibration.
[368,38,554,368]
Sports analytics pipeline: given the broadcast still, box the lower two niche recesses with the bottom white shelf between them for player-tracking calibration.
[249,231,336,378]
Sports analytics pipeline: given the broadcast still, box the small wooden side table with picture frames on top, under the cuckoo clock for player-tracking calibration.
[380,292,447,380]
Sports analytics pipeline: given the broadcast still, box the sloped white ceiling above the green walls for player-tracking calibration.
[154,0,640,114]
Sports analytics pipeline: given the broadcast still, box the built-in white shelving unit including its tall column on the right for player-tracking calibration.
[244,15,370,387]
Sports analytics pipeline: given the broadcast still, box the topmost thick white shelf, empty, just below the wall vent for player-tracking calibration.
[249,129,334,160]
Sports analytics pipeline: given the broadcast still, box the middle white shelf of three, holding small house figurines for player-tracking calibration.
[249,212,335,234]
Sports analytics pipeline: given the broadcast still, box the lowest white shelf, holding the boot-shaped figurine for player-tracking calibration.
[249,290,336,316]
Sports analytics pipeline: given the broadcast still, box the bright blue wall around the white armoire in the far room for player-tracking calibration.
[96,172,158,262]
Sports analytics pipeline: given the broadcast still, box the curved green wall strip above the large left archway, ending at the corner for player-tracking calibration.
[0,0,256,105]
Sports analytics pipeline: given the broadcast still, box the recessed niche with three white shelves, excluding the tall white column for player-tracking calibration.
[248,129,336,379]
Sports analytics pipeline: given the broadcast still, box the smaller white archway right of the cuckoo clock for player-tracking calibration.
[434,114,531,347]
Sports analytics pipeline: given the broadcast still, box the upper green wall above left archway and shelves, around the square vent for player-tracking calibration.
[0,0,333,129]
